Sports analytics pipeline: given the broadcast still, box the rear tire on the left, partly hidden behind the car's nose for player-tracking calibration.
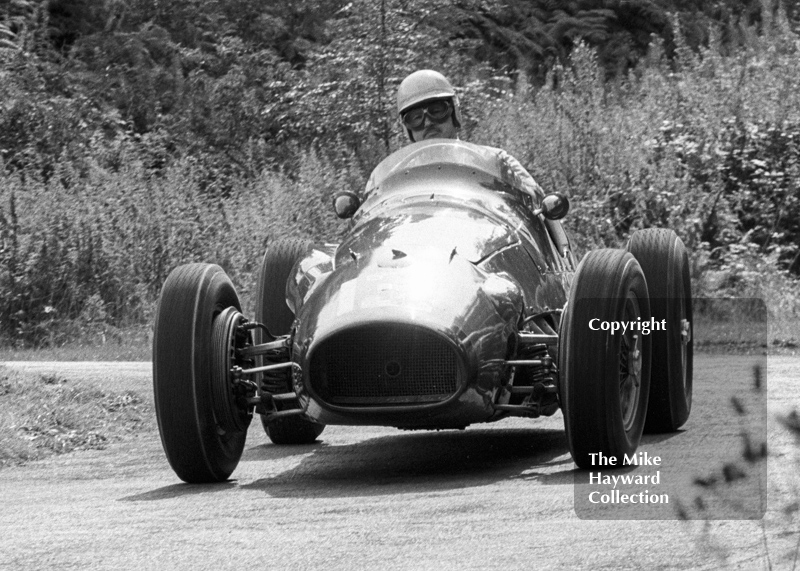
[256,239,325,444]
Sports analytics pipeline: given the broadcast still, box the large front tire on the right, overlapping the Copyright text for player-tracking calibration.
[559,249,651,468]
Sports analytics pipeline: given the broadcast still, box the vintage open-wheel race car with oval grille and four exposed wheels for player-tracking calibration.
[153,139,692,482]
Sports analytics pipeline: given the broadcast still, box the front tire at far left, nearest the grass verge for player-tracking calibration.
[153,264,249,483]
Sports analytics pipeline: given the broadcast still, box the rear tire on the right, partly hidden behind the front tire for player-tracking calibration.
[628,228,694,432]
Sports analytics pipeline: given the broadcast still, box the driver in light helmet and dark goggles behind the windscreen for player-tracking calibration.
[392,69,544,204]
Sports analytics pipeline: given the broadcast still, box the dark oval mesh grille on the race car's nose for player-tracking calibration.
[310,325,461,406]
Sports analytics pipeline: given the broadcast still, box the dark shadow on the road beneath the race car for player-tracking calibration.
[241,429,573,497]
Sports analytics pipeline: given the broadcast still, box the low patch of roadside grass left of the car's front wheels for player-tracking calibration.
[0,367,154,468]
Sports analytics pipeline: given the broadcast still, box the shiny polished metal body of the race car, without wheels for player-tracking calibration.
[287,139,575,428]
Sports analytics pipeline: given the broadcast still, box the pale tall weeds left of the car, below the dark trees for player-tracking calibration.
[0,147,359,344]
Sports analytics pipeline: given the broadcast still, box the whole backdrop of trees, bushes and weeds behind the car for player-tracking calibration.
[0,0,800,345]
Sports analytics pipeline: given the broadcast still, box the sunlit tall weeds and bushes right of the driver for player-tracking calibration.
[473,25,800,337]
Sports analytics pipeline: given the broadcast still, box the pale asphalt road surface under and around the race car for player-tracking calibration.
[0,356,800,571]
